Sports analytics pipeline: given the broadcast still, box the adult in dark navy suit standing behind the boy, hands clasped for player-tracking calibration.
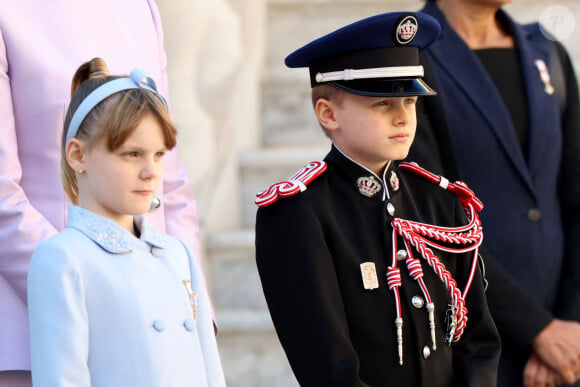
[408,0,580,387]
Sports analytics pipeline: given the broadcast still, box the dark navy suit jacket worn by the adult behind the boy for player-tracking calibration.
[408,2,580,387]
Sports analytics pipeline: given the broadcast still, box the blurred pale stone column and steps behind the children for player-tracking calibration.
[158,0,580,387]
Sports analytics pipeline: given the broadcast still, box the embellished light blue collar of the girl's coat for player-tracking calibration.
[66,205,166,254]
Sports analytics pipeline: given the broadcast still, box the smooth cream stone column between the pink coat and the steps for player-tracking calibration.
[158,0,248,226]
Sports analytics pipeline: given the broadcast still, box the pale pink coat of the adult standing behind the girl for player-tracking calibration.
[0,0,200,371]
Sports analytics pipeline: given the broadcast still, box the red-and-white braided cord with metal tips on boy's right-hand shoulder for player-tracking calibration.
[387,163,483,364]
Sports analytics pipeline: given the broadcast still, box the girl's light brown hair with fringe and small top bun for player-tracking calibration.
[61,58,177,204]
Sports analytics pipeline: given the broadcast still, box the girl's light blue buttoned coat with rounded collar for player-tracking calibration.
[28,206,225,387]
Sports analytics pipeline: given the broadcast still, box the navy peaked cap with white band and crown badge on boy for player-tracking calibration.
[285,12,441,97]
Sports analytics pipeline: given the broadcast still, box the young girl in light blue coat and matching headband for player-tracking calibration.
[28,58,225,387]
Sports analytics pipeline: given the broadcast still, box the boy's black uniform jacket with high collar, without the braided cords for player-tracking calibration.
[256,147,500,386]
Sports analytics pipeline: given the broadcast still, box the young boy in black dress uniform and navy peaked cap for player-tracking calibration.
[256,13,500,386]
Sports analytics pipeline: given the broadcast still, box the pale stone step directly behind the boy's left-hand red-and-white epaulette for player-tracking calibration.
[240,145,330,227]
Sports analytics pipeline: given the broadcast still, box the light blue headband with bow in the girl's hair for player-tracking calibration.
[66,69,167,143]
